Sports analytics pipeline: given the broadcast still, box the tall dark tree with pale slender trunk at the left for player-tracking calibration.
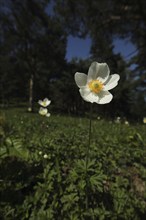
[0,0,66,107]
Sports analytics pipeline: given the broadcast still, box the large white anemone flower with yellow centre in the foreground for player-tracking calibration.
[75,62,120,104]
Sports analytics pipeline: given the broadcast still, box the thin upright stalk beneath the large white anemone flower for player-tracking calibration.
[86,104,92,210]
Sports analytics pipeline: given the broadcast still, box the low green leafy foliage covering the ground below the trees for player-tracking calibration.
[0,109,146,220]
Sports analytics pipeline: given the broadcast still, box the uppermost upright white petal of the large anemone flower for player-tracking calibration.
[88,62,110,83]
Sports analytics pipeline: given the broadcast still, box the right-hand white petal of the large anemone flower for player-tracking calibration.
[104,74,120,91]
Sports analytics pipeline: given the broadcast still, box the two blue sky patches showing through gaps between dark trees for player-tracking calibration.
[66,36,136,61]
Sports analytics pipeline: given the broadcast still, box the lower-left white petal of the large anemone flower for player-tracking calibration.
[79,87,99,103]
